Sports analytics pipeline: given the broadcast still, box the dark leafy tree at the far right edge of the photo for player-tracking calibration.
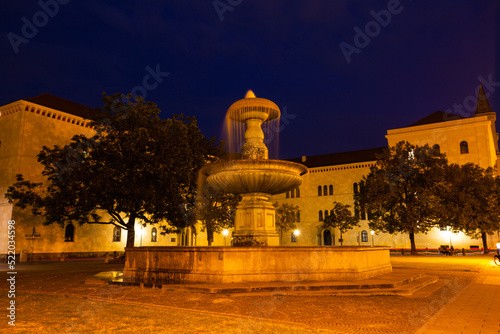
[440,163,500,253]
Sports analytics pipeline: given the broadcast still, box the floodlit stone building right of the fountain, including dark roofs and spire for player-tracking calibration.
[273,86,500,249]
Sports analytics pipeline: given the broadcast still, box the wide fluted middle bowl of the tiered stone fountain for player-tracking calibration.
[203,159,307,195]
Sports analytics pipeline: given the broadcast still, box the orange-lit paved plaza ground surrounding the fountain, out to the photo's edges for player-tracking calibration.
[0,255,500,333]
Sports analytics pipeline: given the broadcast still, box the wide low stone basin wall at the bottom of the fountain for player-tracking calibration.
[123,246,392,283]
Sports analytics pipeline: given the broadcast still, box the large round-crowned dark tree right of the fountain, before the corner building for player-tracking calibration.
[356,141,447,254]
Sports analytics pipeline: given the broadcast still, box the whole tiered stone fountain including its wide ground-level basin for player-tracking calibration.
[123,91,392,283]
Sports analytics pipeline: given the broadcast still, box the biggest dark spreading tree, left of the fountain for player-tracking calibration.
[6,94,222,247]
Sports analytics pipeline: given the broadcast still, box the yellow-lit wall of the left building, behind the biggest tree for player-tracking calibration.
[0,100,97,254]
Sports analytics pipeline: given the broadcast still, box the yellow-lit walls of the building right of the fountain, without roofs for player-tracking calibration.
[272,113,500,249]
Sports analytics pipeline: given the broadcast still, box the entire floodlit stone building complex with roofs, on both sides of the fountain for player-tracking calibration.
[0,87,499,259]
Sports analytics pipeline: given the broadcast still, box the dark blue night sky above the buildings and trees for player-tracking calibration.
[0,0,500,158]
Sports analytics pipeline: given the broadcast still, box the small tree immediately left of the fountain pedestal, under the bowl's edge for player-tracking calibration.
[195,189,241,246]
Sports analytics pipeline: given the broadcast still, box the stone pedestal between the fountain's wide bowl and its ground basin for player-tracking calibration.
[233,193,279,246]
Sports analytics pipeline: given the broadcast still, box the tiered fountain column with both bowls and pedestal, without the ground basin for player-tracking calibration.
[201,90,307,246]
